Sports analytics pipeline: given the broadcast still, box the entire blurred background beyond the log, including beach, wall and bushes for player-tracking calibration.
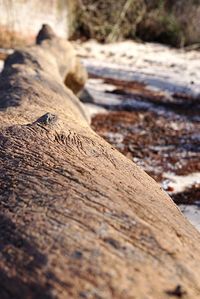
[0,0,200,229]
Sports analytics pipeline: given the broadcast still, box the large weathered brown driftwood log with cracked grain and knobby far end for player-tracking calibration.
[0,26,200,299]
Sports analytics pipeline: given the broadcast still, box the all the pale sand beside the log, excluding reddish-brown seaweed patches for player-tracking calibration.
[75,41,200,230]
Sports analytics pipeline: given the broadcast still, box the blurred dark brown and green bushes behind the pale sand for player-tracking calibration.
[74,0,200,47]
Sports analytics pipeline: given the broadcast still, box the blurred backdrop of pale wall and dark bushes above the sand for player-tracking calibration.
[0,0,200,47]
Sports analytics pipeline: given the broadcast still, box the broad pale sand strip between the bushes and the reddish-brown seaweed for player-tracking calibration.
[76,41,200,96]
